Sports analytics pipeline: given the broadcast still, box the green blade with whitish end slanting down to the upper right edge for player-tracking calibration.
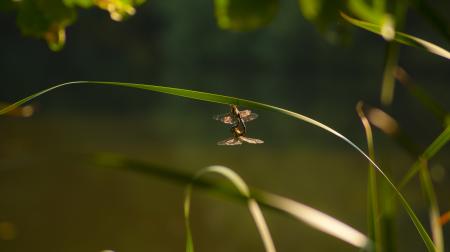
[341,12,450,59]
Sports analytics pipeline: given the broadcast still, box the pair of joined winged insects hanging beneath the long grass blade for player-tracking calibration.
[213,105,264,145]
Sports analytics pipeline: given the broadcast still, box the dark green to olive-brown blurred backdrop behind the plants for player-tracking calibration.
[0,0,450,252]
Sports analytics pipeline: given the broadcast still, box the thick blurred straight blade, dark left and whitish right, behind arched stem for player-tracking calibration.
[96,154,372,250]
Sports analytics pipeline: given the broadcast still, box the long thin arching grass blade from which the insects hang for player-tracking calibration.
[0,81,435,251]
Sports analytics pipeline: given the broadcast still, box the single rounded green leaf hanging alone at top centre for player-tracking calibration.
[214,0,279,31]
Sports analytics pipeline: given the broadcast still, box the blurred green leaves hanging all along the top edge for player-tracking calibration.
[0,0,449,51]
